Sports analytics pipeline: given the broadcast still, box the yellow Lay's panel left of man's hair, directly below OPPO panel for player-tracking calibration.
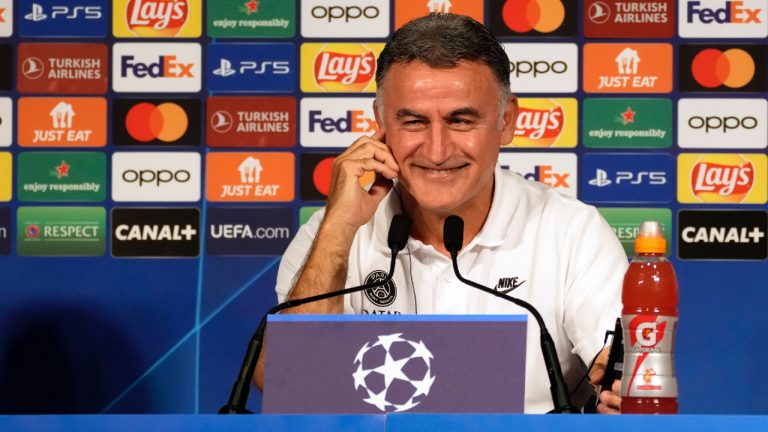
[301,43,384,93]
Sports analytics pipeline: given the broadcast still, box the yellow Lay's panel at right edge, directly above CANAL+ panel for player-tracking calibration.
[677,153,768,204]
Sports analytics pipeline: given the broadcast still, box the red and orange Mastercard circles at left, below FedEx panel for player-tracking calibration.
[125,102,189,142]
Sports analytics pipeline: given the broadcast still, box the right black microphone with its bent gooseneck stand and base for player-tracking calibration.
[443,215,580,414]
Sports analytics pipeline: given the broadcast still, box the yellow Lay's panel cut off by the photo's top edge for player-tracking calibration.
[112,0,203,38]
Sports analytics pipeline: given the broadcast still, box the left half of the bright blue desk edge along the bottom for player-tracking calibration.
[0,414,386,432]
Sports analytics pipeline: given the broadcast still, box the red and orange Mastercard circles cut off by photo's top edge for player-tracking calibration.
[501,0,565,33]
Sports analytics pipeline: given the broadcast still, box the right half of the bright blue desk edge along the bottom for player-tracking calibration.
[387,414,768,432]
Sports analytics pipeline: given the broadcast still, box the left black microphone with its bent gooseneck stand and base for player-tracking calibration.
[219,214,411,414]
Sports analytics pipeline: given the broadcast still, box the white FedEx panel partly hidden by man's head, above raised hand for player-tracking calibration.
[299,97,378,148]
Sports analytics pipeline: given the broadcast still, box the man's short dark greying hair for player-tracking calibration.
[376,13,510,99]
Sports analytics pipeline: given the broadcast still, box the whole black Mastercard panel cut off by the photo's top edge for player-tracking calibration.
[491,0,577,36]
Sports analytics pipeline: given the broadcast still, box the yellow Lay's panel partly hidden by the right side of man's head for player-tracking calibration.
[504,98,579,148]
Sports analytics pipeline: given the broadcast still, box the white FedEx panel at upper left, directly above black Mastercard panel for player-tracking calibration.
[112,43,202,93]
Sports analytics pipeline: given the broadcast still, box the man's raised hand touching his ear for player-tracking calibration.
[325,128,400,233]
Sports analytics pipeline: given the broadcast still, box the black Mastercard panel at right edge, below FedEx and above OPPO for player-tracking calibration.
[679,45,768,92]
